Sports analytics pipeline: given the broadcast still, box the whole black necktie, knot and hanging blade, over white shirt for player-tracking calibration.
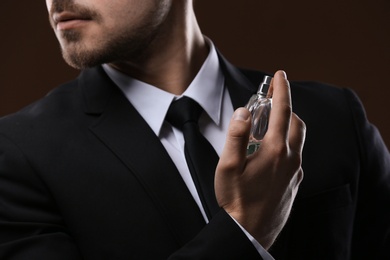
[166,97,219,219]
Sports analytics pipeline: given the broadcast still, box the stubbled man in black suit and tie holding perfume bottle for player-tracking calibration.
[0,0,390,259]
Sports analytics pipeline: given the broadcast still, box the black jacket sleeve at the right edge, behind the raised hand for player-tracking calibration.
[345,89,390,259]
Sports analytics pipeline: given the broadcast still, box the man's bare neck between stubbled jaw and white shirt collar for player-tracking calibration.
[106,2,209,95]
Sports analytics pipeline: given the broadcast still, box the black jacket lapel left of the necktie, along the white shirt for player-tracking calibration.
[80,68,205,245]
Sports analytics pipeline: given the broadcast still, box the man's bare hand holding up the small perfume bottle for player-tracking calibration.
[215,71,306,249]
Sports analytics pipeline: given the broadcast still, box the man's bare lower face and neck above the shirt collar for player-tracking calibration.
[46,0,208,94]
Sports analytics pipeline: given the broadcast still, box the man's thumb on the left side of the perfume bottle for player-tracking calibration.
[218,108,251,172]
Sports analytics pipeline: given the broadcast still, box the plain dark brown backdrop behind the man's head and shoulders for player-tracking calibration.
[0,0,390,147]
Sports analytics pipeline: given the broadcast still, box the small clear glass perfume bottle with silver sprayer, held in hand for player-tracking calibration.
[245,76,272,155]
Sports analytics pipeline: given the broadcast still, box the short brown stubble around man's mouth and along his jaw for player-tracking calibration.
[50,0,171,69]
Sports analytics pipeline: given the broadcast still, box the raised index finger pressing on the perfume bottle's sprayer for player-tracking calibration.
[267,70,292,144]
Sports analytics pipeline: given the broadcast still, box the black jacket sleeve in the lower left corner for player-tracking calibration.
[0,134,81,260]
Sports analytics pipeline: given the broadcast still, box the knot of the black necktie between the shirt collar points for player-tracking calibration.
[166,97,203,129]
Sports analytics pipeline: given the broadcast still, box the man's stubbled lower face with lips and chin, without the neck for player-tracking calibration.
[46,0,170,68]
